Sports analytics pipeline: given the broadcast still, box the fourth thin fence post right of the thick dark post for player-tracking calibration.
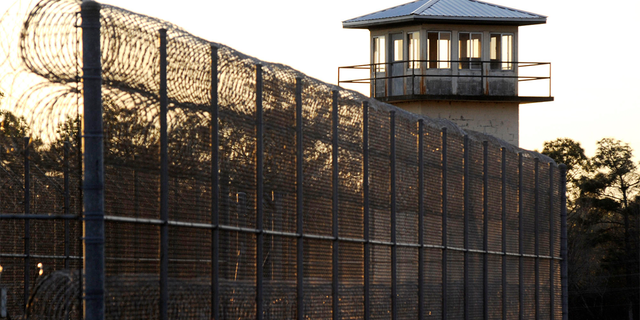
[296,77,304,320]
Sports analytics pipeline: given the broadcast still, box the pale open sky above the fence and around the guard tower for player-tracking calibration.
[0,0,640,159]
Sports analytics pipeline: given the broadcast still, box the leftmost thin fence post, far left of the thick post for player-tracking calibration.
[23,137,31,314]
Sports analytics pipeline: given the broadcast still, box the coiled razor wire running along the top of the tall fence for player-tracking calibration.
[0,0,552,159]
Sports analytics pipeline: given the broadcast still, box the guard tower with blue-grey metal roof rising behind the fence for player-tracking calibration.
[338,0,553,145]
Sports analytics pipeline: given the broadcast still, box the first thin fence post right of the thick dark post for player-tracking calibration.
[158,29,169,320]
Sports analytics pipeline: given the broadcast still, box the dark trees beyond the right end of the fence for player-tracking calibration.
[542,138,640,320]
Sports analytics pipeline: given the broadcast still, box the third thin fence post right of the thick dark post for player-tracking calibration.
[256,64,264,320]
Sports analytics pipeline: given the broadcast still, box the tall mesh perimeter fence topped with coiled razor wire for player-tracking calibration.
[0,0,567,319]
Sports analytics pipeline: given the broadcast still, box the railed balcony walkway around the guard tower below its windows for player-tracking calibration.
[338,59,554,104]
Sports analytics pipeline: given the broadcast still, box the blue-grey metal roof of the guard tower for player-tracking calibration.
[342,0,547,29]
